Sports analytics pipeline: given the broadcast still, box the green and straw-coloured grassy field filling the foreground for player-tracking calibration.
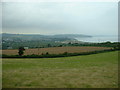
[2,51,118,88]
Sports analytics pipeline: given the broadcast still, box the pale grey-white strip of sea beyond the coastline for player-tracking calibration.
[76,35,120,43]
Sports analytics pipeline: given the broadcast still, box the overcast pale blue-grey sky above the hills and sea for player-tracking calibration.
[2,2,118,35]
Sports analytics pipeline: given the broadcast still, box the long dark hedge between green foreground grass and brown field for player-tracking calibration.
[2,49,118,58]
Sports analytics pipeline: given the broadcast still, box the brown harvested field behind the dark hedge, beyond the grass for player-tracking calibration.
[2,46,111,55]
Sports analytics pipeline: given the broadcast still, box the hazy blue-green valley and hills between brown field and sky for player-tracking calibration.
[0,33,90,49]
